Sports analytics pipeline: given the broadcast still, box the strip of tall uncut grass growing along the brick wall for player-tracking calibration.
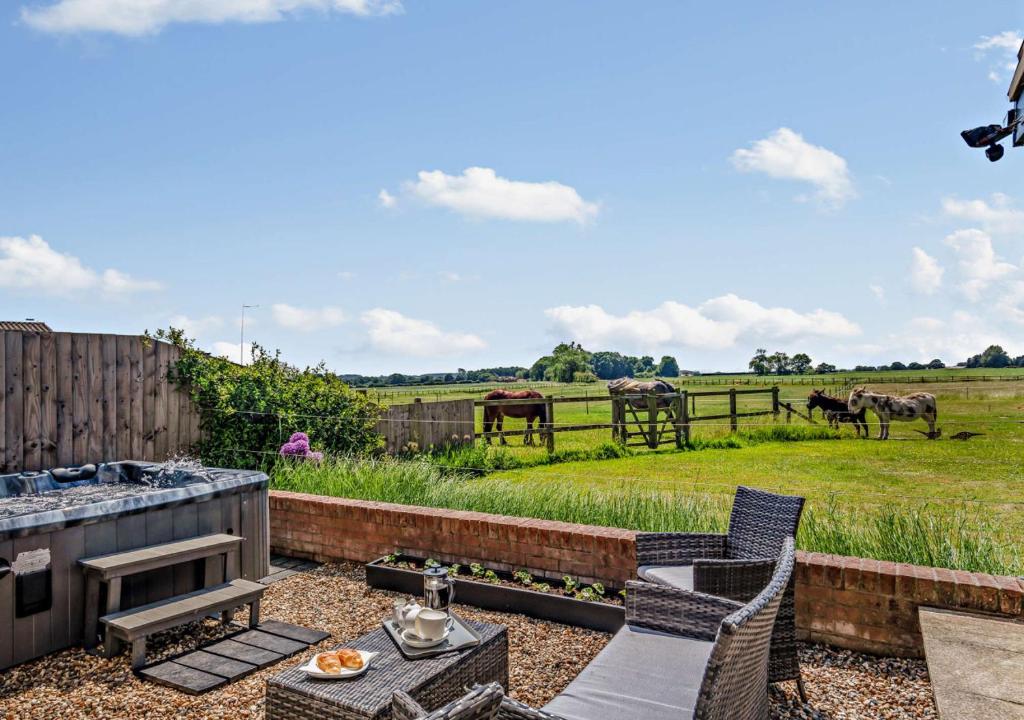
[272,458,1024,575]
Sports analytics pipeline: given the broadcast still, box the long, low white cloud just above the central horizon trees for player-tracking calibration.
[545,293,860,351]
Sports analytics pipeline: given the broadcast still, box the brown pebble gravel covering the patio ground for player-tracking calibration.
[0,564,936,720]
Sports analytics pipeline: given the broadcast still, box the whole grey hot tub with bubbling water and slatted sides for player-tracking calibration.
[0,461,269,670]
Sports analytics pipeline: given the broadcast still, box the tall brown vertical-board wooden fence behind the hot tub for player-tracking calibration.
[0,331,200,473]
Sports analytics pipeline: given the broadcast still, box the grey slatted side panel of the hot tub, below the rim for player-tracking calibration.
[0,488,269,670]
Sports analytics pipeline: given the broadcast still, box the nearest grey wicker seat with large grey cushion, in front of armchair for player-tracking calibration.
[498,538,795,720]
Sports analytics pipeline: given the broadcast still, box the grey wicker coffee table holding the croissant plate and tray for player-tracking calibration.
[266,621,509,720]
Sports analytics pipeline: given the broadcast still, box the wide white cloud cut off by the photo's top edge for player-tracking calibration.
[22,0,402,36]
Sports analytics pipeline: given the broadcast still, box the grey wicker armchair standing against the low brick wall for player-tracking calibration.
[636,485,806,701]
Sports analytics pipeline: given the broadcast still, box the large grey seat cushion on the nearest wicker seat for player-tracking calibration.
[544,625,714,720]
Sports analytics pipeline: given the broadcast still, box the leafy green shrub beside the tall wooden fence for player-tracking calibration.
[155,328,383,468]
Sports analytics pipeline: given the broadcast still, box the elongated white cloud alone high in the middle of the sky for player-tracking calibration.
[406,167,598,224]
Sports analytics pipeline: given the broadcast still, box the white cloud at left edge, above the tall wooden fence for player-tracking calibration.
[0,235,161,298]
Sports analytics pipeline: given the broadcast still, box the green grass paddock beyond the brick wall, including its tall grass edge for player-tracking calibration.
[274,370,1024,575]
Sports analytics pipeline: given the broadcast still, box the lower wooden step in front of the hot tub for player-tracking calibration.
[99,579,266,669]
